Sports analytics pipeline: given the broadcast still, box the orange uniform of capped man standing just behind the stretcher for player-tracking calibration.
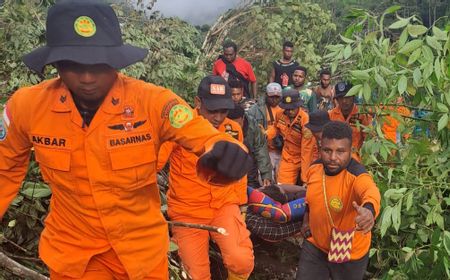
[268,109,316,184]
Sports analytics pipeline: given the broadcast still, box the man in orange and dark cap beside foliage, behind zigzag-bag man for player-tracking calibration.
[328,82,372,161]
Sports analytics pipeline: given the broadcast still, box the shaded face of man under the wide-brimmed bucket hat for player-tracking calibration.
[56,61,117,106]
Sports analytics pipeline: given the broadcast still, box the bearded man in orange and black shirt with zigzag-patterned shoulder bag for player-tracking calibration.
[297,121,381,280]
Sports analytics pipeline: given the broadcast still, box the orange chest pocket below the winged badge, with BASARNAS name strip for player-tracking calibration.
[108,133,157,190]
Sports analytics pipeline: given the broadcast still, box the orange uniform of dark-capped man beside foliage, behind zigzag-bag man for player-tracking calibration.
[328,104,372,161]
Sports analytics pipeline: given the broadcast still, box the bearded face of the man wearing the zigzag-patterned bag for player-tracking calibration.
[320,138,352,174]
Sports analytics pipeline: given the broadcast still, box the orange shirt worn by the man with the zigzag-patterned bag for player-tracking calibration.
[306,159,381,260]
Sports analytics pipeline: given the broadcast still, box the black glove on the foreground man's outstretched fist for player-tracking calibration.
[199,141,252,181]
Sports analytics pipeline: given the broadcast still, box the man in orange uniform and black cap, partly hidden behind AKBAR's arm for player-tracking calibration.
[158,76,254,280]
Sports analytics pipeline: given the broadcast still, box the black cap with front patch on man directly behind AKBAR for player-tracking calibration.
[197,75,234,111]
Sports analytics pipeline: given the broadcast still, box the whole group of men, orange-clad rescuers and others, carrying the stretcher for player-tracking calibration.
[0,1,406,280]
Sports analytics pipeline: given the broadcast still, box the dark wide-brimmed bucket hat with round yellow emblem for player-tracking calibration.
[23,0,148,73]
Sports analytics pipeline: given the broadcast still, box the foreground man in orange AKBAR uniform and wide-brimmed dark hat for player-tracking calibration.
[0,1,251,280]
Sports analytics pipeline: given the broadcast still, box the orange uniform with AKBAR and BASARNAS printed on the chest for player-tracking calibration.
[0,74,239,279]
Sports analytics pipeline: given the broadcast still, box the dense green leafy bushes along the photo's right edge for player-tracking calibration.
[325,7,450,279]
